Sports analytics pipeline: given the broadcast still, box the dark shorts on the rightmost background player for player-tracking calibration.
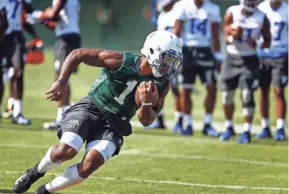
[260,57,288,88]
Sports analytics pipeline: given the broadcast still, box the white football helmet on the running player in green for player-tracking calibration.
[141,30,183,80]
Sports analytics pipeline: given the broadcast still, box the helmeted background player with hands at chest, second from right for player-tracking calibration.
[220,0,271,143]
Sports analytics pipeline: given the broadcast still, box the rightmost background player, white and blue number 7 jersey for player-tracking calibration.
[257,0,288,141]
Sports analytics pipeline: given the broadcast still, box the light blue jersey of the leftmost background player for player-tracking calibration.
[5,0,23,34]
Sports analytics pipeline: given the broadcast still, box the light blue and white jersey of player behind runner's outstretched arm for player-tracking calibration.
[52,0,80,37]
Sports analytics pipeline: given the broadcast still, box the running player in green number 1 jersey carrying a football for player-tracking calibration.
[14,31,182,194]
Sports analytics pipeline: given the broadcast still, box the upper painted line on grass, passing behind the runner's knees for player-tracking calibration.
[0,144,288,167]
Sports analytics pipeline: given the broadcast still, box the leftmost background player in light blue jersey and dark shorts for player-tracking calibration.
[0,0,31,125]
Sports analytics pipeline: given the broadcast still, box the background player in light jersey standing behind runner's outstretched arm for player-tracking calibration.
[29,0,81,129]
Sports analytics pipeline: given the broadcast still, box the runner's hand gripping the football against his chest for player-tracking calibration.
[137,81,157,103]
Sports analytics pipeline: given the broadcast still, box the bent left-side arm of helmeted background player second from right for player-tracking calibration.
[224,11,242,44]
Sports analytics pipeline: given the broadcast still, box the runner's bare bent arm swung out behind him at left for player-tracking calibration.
[46,48,123,101]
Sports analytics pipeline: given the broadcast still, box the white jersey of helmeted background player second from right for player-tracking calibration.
[227,5,265,56]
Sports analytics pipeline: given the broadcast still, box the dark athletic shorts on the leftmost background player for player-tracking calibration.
[0,31,26,69]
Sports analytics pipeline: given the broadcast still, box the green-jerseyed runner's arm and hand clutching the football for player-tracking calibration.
[138,81,170,126]
